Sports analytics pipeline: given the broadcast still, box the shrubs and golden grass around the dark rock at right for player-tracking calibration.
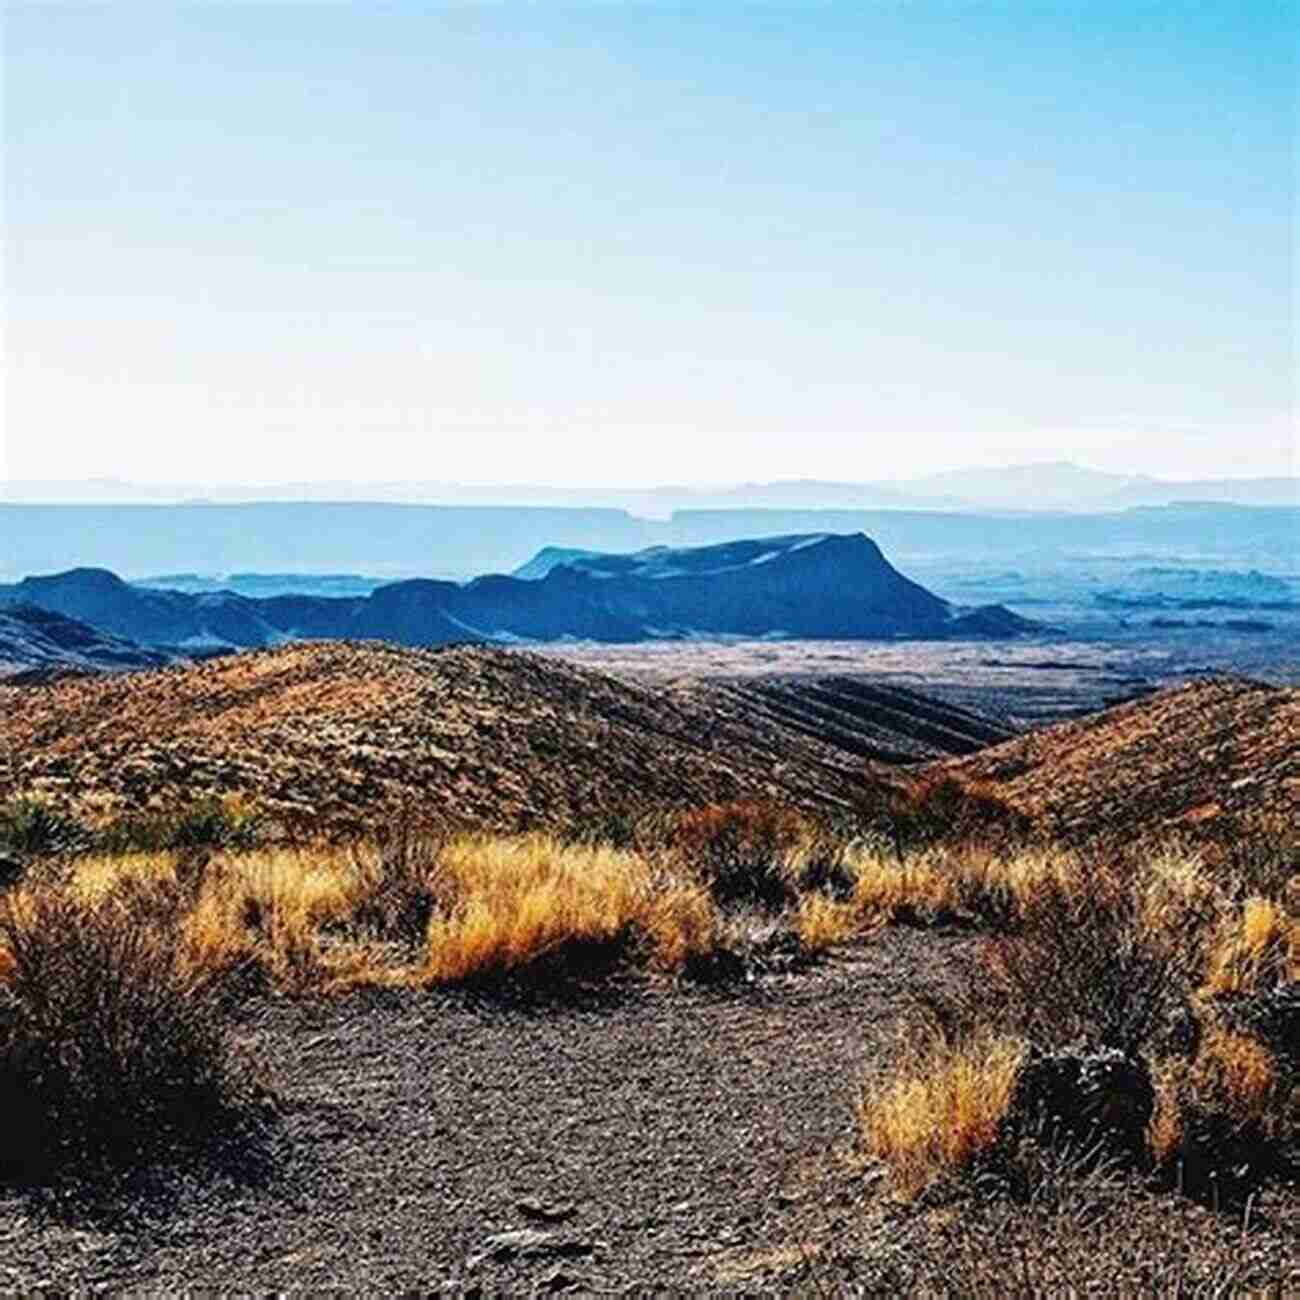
[859,832,1300,1201]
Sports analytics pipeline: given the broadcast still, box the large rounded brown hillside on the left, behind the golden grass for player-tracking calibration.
[0,642,894,828]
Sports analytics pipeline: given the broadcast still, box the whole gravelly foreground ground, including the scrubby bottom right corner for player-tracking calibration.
[0,930,1300,1296]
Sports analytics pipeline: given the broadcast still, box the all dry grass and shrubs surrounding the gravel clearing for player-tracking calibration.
[0,764,1300,1294]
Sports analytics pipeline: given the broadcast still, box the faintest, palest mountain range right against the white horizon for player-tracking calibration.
[0,462,1300,517]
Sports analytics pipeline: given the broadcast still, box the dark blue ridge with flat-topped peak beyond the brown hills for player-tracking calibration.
[0,533,1043,653]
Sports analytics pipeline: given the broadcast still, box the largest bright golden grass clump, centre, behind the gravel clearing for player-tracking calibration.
[423,835,715,983]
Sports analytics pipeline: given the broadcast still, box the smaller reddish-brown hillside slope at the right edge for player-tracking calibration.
[927,677,1300,836]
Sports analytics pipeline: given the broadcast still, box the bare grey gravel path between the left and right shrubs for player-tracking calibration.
[0,931,956,1294]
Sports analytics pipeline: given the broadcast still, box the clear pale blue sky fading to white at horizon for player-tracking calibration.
[0,0,1300,486]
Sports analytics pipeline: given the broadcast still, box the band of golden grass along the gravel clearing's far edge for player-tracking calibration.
[0,826,1284,997]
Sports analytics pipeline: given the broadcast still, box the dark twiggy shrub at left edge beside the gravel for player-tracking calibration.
[0,889,260,1179]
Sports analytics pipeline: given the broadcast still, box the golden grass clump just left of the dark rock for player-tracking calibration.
[859,1034,1024,1200]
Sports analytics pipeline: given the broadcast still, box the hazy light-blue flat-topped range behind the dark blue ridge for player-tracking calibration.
[0,502,1300,585]
